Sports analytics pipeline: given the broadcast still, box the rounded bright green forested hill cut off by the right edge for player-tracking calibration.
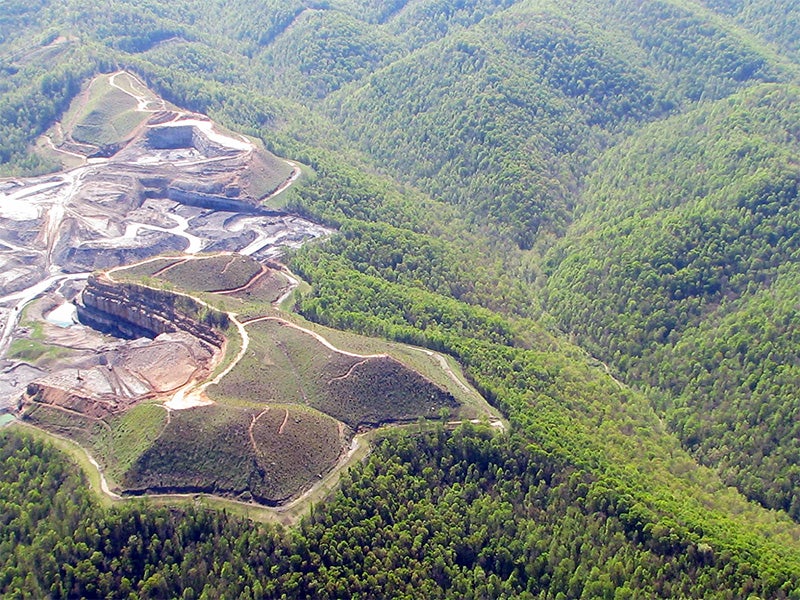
[547,85,800,519]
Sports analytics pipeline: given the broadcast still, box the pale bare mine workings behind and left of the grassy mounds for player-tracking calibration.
[0,73,329,412]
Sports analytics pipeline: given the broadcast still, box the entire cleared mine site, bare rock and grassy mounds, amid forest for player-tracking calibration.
[0,73,500,518]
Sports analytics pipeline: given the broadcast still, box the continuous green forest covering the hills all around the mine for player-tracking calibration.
[0,0,800,598]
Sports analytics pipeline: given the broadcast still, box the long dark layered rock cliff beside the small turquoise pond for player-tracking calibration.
[78,275,228,348]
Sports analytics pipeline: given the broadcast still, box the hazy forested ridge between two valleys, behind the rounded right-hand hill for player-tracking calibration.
[318,2,778,248]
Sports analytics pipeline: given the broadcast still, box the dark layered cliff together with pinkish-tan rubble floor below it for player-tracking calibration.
[27,275,228,419]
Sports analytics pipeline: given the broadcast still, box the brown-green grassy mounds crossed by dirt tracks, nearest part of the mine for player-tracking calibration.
[25,254,494,506]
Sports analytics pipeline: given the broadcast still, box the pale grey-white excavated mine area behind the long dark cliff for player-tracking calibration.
[0,75,299,300]
